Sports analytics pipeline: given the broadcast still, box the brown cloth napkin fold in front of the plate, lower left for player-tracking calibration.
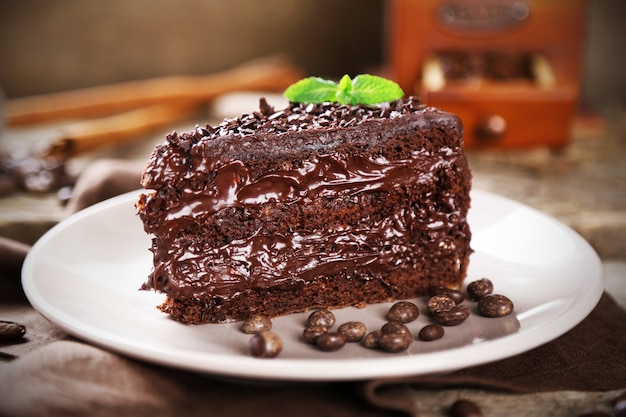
[0,340,388,417]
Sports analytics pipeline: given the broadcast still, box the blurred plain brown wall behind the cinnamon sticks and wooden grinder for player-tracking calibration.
[0,0,626,111]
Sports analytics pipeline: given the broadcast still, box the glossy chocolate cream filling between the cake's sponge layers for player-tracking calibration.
[144,152,459,298]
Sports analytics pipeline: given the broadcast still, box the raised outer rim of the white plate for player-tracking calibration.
[22,189,604,381]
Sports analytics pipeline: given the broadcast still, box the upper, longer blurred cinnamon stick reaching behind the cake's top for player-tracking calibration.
[5,56,301,126]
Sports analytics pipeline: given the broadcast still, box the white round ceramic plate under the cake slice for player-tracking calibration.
[22,191,603,381]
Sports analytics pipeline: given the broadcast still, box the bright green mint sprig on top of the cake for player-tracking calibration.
[284,74,404,105]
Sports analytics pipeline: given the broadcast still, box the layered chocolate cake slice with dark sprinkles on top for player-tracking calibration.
[137,98,471,323]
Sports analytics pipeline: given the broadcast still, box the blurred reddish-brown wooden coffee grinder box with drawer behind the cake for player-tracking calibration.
[389,0,586,148]
